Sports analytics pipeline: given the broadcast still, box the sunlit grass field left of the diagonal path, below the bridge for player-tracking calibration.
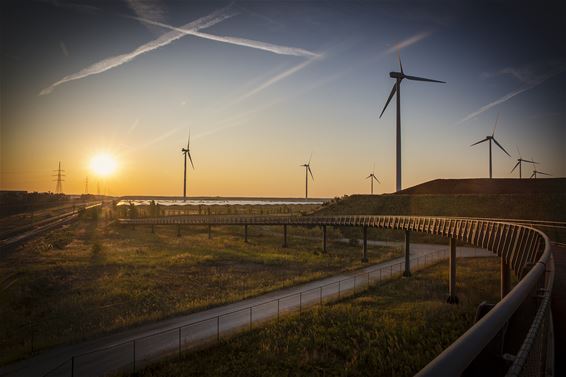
[0,217,402,364]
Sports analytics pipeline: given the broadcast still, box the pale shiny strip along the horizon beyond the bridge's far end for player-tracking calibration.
[117,199,324,206]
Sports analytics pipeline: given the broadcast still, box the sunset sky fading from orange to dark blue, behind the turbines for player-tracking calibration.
[0,0,566,197]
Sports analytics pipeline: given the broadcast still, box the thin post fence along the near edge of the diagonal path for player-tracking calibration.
[44,249,454,377]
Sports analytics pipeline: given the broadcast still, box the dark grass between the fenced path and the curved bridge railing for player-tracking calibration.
[136,258,498,377]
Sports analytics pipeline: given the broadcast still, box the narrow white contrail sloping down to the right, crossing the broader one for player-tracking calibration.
[128,16,319,58]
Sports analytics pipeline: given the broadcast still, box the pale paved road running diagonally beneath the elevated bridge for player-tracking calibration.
[0,244,493,377]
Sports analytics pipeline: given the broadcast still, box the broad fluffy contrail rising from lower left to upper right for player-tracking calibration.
[39,8,236,95]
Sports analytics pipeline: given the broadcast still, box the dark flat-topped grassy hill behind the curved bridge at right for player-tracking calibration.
[315,179,566,241]
